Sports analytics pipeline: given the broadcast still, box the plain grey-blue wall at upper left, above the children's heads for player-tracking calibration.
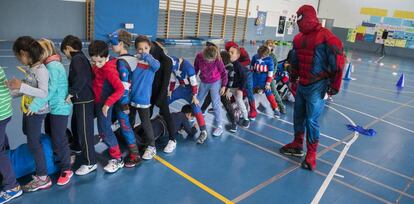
[0,0,86,41]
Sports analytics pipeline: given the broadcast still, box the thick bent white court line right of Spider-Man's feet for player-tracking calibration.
[311,107,359,204]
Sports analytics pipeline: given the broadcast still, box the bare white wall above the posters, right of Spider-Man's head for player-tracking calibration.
[319,0,414,28]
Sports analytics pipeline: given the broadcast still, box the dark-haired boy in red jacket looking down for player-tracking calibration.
[88,40,125,173]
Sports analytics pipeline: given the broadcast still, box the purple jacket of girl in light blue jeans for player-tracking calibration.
[194,52,227,87]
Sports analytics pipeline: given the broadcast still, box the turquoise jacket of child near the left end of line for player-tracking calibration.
[29,58,72,115]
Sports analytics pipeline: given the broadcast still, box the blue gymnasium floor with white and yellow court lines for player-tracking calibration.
[0,42,414,204]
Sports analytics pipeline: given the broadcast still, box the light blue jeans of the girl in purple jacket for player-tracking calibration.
[197,80,222,127]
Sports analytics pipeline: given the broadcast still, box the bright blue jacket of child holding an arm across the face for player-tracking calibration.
[130,54,160,107]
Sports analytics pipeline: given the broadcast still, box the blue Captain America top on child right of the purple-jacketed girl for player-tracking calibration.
[250,54,275,87]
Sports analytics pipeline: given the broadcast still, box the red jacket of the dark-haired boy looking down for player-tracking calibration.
[92,58,125,106]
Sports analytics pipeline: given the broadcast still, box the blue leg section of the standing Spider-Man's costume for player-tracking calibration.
[293,80,327,143]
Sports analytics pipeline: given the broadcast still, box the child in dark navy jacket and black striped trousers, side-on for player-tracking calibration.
[60,35,97,176]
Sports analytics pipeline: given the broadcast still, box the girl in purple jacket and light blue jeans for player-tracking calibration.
[194,46,227,144]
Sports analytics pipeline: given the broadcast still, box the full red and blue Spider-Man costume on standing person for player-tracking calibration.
[280,5,345,170]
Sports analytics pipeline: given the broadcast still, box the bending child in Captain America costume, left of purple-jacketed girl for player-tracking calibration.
[164,57,207,150]
